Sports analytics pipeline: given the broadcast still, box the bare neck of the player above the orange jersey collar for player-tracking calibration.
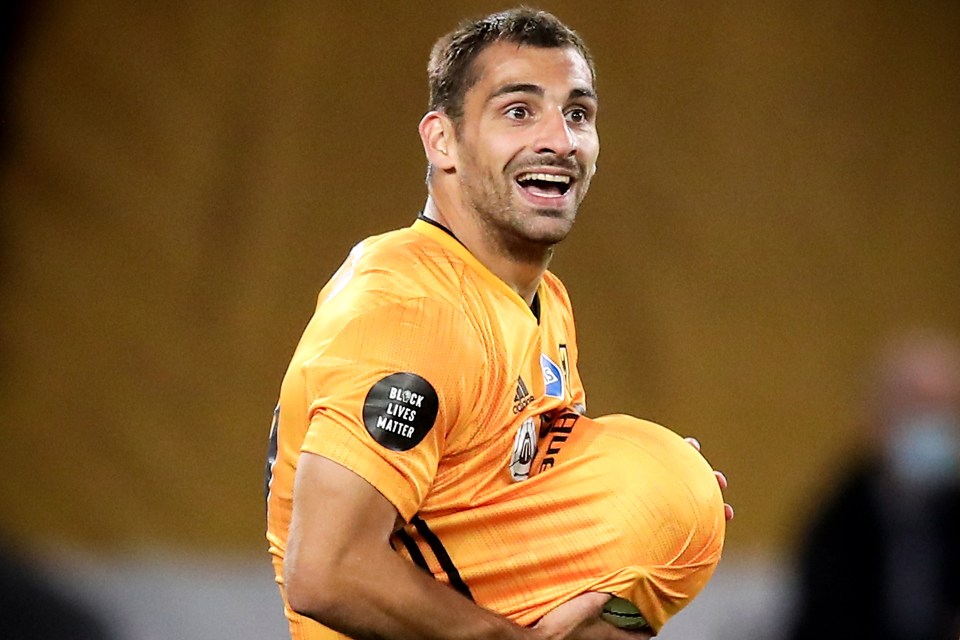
[423,193,553,305]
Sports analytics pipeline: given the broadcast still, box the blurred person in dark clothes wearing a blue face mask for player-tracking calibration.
[787,330,960,640]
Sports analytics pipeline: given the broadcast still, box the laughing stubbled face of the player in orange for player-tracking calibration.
[456,42,600,258]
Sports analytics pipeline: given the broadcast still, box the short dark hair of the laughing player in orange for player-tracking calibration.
[427,7,597,121]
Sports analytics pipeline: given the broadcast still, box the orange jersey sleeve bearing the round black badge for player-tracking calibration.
[301,298,482,520]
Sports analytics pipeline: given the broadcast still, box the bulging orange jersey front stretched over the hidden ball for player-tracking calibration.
[397,414,725,631]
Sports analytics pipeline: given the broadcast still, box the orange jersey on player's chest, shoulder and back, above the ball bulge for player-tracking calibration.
[267,220,584,638]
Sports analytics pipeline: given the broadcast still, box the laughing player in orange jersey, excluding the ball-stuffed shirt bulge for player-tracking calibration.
[268,9,729,640]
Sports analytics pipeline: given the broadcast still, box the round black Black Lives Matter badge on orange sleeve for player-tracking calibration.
[363,373,440,451]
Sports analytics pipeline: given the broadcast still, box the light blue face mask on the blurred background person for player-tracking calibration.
[888,412,960,488]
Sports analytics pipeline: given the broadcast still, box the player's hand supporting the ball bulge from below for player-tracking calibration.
[533,591,653,640]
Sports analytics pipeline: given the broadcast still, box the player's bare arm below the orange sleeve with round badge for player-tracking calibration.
[284,453,541,640]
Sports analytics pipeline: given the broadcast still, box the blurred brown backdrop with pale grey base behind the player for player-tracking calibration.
[0,0,960,640]
